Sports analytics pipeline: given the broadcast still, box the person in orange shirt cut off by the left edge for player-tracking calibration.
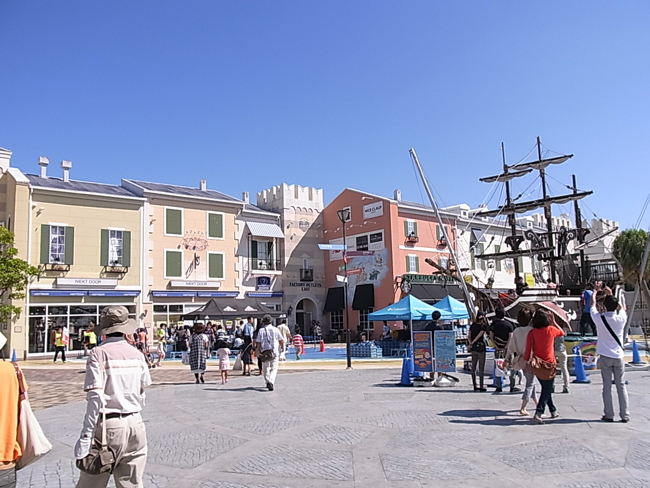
[0,361,27,488]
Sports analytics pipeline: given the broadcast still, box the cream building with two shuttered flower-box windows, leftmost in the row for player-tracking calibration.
[0,154,144,358]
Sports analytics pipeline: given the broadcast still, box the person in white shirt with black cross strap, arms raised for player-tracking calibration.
[591,285,630,423]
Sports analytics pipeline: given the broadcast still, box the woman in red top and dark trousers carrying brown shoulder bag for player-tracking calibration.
[524,308,565,424]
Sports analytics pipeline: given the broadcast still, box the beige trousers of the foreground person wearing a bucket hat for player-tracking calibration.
[77,413,147,488]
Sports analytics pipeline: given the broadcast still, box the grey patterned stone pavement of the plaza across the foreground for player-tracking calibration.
[18,365,650,488]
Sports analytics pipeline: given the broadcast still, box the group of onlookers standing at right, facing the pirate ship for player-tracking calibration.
[468,283,630,424]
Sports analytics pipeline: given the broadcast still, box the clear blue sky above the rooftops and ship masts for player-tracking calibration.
[0,0,650,227]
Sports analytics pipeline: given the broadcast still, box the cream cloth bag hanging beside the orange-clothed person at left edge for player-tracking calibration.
[12,363,52,469]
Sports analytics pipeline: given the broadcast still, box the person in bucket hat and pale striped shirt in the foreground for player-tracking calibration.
[74,307,151,488]
